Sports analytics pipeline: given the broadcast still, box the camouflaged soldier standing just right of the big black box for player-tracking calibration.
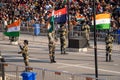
[82,21,90,47]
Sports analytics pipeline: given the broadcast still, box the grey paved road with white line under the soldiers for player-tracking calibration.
[0,34,120,80]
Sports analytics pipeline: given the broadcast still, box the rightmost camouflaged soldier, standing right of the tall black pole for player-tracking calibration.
[105,33,113,62]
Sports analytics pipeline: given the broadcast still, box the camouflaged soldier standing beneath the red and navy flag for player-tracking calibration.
[59,25,67,54]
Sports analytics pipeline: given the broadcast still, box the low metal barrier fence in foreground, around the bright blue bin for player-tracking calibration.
[0,63,105,80]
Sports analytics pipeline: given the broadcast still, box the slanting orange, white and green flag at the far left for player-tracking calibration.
[4,20,21,37]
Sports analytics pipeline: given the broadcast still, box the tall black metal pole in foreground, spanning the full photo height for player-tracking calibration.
[93,0,98,80]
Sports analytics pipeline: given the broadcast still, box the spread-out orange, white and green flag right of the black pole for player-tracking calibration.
[92,13,111,29]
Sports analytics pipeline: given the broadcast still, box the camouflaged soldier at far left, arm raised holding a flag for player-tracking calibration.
[18,40,29,71]
